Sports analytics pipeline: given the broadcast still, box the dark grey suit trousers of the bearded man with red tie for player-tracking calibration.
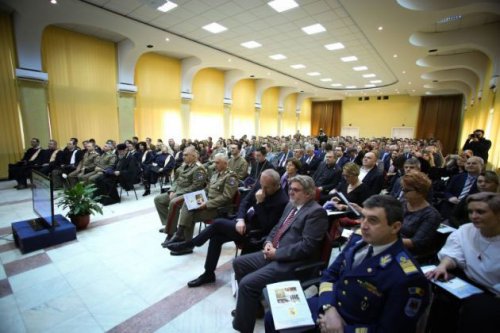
[233,252,297,333]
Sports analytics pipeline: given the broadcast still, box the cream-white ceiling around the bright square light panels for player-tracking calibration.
[1,0,500,98]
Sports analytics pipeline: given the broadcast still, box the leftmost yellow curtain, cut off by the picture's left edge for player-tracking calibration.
[0,13,23,178]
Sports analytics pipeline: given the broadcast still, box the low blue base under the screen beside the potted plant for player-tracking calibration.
[12,215,76,253]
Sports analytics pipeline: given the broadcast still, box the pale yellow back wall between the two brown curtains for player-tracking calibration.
[341,96,420,137]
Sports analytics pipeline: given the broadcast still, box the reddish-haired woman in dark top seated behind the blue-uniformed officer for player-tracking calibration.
[400,171,441,255]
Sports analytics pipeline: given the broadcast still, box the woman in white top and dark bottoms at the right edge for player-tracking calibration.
[426,192,500,333]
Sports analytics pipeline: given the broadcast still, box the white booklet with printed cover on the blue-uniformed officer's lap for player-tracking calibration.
[266,281,314,332]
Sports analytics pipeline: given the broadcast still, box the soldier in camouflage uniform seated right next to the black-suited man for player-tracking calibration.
[166,154,238,255]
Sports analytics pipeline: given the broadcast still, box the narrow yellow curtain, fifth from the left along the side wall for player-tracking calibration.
[230,79,255,138]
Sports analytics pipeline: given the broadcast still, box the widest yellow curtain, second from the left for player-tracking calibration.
[42,27,118,144]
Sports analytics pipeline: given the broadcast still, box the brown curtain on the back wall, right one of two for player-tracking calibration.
[416,95,463,155]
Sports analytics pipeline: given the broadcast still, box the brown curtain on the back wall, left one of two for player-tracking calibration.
[311,101,342,136]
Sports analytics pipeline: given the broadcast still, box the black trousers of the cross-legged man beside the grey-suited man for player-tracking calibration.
[193,218,245,273]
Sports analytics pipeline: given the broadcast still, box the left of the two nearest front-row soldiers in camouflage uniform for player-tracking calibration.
[154,146,207,245]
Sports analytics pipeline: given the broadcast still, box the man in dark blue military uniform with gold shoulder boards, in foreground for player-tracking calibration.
[266,195,430,333]
